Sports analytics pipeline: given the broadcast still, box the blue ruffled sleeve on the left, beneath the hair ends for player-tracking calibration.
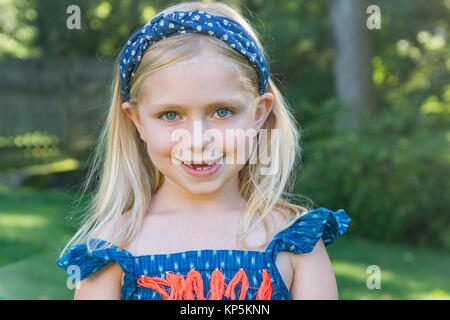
[56,239,133,280]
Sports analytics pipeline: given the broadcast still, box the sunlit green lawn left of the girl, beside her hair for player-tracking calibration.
[0,184,81,299]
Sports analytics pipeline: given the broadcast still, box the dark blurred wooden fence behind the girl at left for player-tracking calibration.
[0,57,114,172]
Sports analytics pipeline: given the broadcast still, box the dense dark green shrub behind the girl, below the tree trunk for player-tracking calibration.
[296,104,450,249]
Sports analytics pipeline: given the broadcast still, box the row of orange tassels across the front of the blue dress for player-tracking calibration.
[137,268,273,300]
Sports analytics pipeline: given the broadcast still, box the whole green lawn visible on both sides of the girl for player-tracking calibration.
[0,185,450,299]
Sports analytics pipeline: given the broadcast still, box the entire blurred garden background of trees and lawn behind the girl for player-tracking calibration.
[0,0,450,299]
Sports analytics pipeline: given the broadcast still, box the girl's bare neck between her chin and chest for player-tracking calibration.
[150,177,245,215]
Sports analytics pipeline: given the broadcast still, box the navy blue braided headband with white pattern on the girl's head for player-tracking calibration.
[120,10,269,101]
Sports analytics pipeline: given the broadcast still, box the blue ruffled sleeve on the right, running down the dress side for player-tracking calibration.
[266,208,351,300]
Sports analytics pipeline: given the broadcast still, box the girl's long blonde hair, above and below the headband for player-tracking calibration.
[61,2,308,255]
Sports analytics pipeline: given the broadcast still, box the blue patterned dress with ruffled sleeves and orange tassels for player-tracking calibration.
[56,208,351,300]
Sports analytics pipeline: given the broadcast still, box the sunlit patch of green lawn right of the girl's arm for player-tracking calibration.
[327,235,450,300]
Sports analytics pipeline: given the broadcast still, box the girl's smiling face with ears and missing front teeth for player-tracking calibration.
[122,55,273,194]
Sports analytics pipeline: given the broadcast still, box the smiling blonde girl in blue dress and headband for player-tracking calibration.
[57,2,350,300]
